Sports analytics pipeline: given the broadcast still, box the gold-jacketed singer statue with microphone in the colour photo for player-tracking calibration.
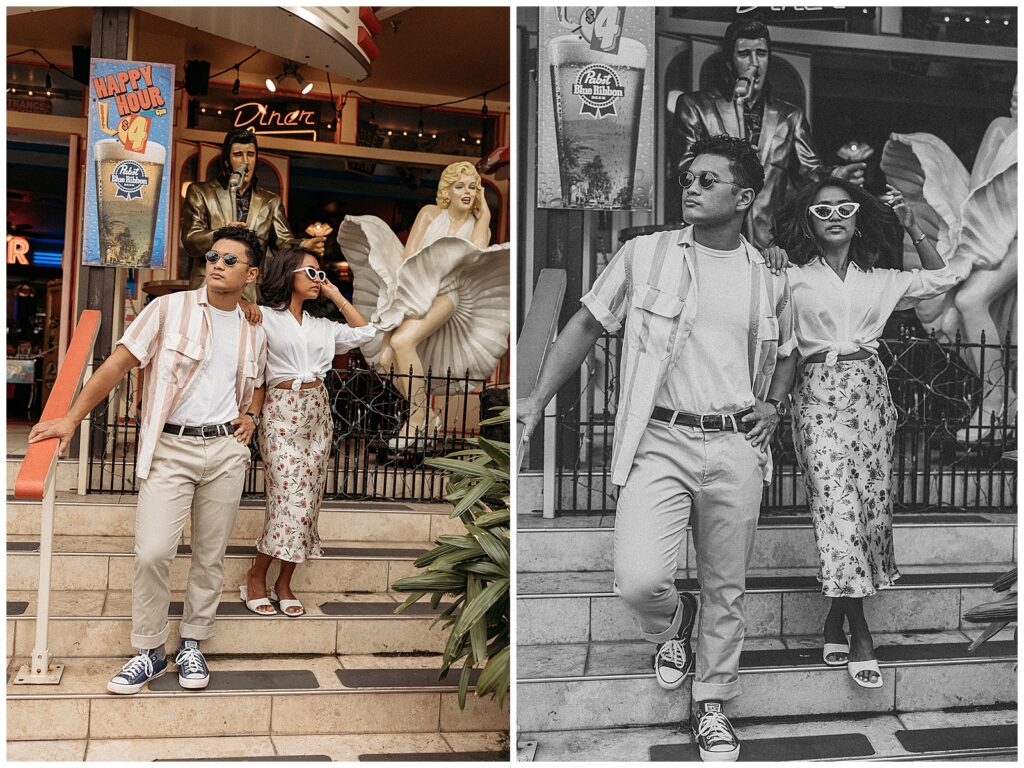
[181,130,325,302]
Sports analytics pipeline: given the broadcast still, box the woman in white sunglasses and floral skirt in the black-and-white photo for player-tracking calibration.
[769,178,964,688]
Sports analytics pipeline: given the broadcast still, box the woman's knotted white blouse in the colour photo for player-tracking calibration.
[260,306,377,389]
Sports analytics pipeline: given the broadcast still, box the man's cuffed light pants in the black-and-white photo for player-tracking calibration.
[614,421,768,701]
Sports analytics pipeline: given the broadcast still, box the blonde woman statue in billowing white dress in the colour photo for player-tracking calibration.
[338,162,509,451]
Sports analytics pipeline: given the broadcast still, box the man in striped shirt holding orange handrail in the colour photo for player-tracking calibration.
[29,226,266,693]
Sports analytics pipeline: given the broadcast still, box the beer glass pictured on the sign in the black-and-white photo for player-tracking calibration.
[548,35,647,208]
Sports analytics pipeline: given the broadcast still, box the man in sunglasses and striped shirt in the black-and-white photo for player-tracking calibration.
[518,136,796,760]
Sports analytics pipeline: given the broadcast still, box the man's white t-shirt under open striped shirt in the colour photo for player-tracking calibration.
[167,304,246,427]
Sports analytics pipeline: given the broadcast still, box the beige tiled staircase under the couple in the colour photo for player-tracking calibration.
[7,466,509,760]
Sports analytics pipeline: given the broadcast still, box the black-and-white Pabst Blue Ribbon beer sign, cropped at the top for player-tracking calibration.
[538,6,654,210]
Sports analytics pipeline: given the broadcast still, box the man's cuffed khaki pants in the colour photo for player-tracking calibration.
[131,433,250,648]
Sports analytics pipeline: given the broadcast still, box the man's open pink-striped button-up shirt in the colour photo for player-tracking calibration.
[118,286,266,478]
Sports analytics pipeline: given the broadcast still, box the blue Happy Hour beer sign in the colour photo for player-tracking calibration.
[82,58,174,269]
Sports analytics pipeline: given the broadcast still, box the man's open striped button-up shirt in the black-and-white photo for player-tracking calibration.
[581,226,797,485]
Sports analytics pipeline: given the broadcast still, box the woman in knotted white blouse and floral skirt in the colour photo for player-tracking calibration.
[240,249,375,616]
